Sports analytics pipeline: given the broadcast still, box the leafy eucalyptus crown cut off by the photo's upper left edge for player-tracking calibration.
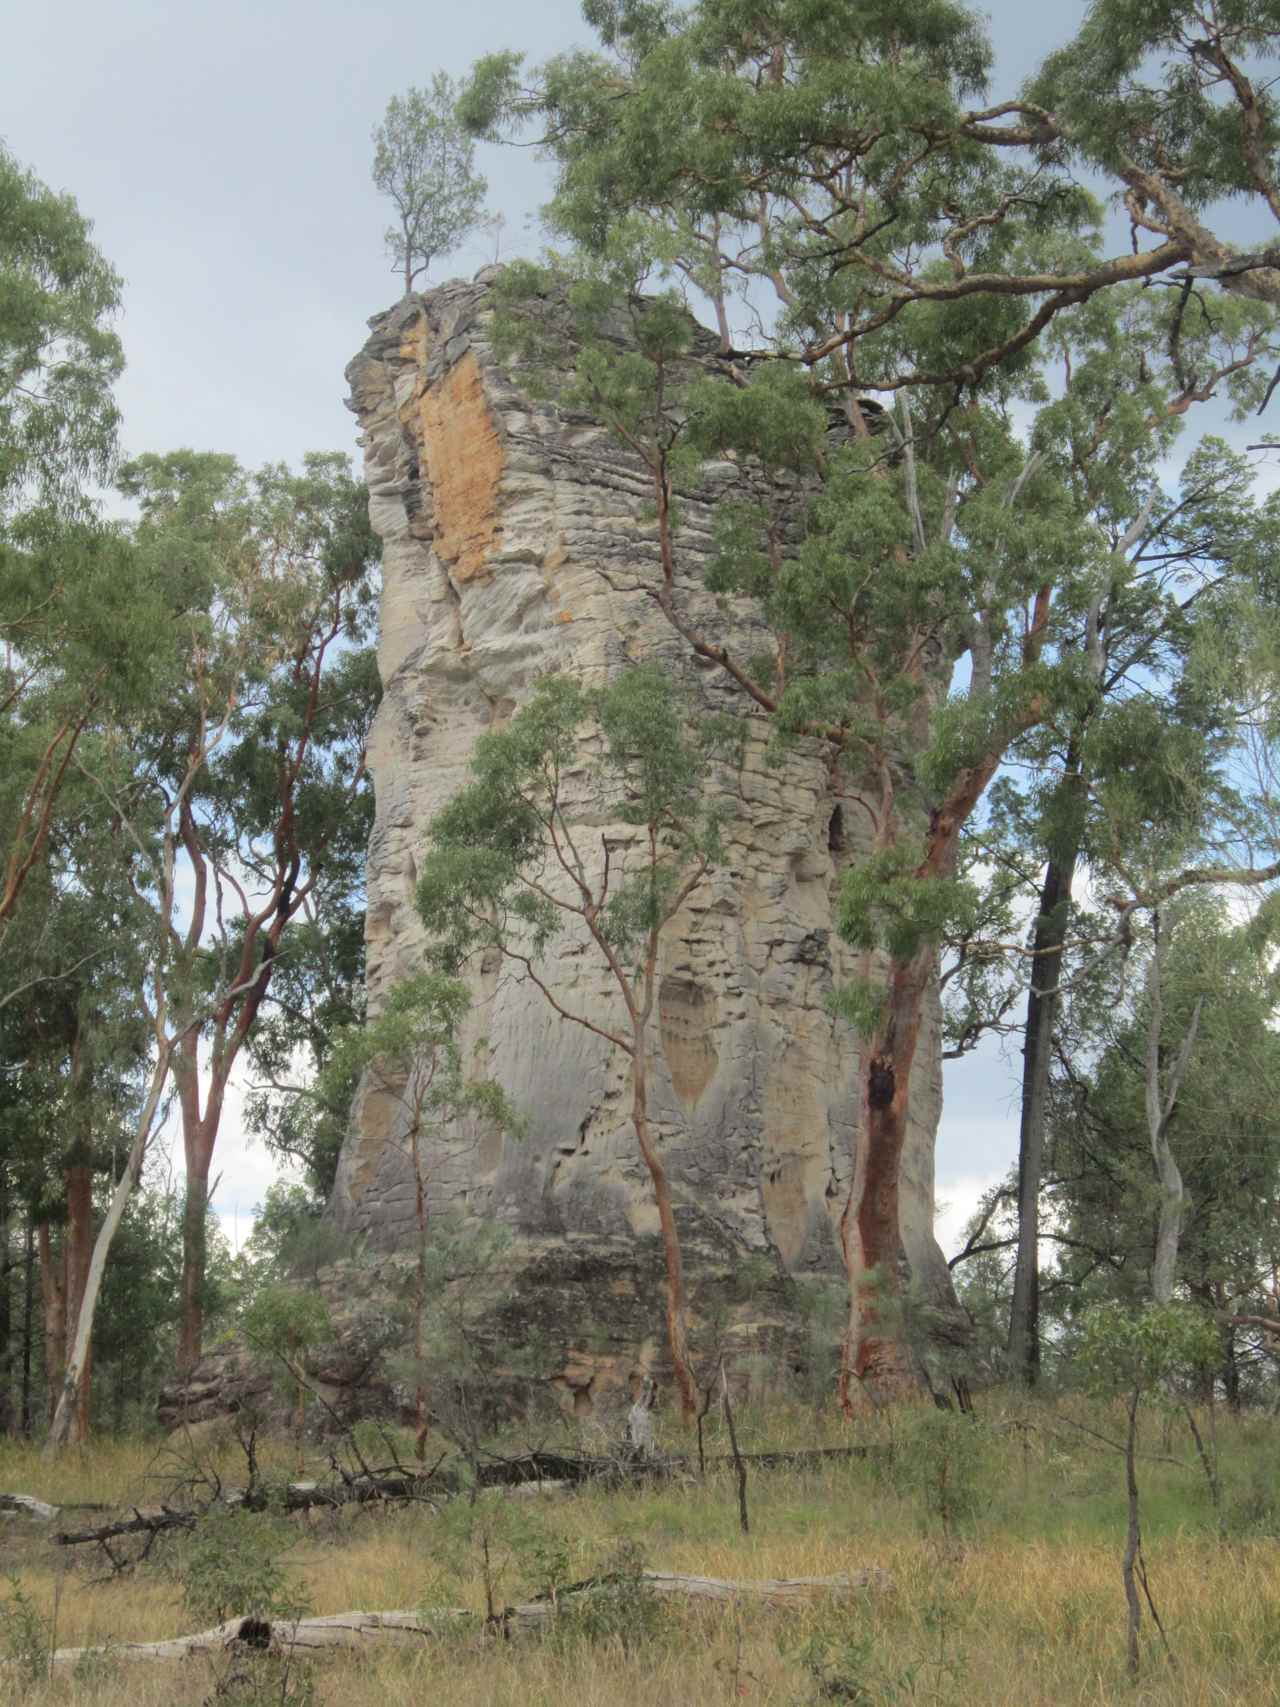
[0,147,160,955]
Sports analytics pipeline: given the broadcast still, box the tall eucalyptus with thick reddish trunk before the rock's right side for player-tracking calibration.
[461,0,1271,1395]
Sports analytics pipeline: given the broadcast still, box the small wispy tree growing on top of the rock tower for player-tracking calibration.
[374,72,488,295]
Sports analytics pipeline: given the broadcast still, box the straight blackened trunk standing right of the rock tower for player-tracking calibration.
[1009,852,1075,1386]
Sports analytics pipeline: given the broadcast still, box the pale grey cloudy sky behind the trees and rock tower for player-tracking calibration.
[0,0,1105,1231]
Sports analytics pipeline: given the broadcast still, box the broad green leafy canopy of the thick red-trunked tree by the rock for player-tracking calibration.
[463,0,1275,1071]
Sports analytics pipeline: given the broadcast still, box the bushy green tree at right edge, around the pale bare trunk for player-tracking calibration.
[1046,896,1280,1403]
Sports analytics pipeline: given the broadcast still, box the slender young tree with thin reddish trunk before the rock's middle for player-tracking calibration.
[418,666,720,1415]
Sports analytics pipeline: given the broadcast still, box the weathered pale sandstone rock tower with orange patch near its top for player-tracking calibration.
[333,273,947,1381]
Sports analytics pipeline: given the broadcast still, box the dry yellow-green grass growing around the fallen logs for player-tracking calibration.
[0,1403,1280,1707]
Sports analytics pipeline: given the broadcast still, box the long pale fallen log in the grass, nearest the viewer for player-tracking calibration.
[37,1565,893,1671]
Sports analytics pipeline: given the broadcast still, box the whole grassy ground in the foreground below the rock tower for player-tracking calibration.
[0,1395,1280,1707]
